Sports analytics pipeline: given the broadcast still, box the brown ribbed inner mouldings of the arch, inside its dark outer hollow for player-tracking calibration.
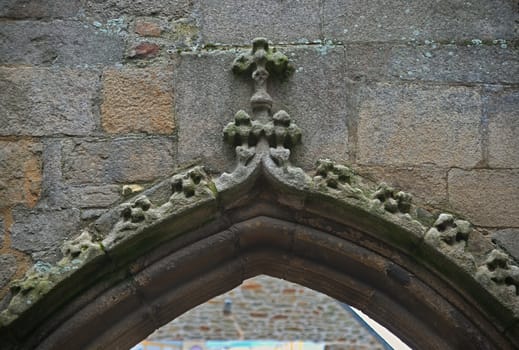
[27,208,506,349]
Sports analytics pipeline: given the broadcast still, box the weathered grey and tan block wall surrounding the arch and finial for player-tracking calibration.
[0,0,519,340]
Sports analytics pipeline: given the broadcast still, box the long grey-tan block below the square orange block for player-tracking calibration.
[63,137,176,184]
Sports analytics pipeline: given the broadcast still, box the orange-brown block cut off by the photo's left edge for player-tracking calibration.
[0,140,42,208]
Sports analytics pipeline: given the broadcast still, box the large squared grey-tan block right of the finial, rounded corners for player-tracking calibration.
[357,84,482,167]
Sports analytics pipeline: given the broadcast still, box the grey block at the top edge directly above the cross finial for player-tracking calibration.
[201,0,320,45]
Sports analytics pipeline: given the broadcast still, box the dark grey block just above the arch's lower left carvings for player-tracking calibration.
[11,206,80,262]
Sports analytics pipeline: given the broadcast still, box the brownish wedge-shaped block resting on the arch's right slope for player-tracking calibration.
[356,165,447,205]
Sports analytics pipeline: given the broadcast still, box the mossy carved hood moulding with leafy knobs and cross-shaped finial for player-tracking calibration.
[0,38,519,344]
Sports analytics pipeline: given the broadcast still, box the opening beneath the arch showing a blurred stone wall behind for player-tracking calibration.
[132,275,409,350]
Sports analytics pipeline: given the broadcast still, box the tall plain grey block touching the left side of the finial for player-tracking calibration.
[174,52,252,171]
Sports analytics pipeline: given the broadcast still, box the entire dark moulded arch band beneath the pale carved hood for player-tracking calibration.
[4,168,517,349]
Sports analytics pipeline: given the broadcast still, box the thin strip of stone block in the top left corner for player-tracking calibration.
[0,0,81,19]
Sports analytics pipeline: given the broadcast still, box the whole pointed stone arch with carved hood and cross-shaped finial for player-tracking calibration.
[0,39,519,349]
